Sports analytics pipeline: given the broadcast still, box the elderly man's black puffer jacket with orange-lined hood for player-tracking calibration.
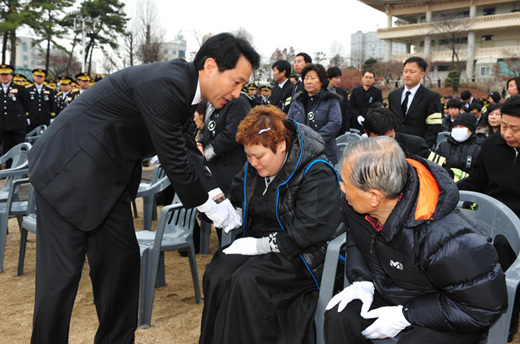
[344,158,507,332]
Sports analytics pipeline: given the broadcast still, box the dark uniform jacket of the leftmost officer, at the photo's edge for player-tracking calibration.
[0,82,29,130]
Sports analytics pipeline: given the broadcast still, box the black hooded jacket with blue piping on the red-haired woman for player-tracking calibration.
[230,120,341,269]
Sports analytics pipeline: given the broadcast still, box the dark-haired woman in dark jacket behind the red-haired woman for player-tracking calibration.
[287,63,342,164]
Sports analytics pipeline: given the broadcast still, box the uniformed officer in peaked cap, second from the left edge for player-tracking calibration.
[25,68,56,132]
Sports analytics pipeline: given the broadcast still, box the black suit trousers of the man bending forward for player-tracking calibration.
[31,191,140,344]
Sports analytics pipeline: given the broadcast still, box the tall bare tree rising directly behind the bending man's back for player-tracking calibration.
[137,0,164,63]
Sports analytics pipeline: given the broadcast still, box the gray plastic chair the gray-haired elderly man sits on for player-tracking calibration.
[315,191,520,344]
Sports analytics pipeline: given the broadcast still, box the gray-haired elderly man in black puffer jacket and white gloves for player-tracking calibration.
[325,137,507,344]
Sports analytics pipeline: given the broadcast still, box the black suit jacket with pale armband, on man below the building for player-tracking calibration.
[388,85,442,147]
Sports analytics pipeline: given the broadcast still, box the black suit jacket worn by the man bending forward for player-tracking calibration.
[29,60,216,231]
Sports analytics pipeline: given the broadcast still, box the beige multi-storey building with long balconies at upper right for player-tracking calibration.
[360,0,520,82]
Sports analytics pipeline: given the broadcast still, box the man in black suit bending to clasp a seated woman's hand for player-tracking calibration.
[29,33,260,344]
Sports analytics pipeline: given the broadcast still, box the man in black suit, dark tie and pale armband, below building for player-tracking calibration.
[388,56,442,147]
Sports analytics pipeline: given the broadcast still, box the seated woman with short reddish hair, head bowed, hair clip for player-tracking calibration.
[200,106,340,344]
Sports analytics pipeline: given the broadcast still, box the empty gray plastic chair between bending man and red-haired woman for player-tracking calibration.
[136,200,202,328]
